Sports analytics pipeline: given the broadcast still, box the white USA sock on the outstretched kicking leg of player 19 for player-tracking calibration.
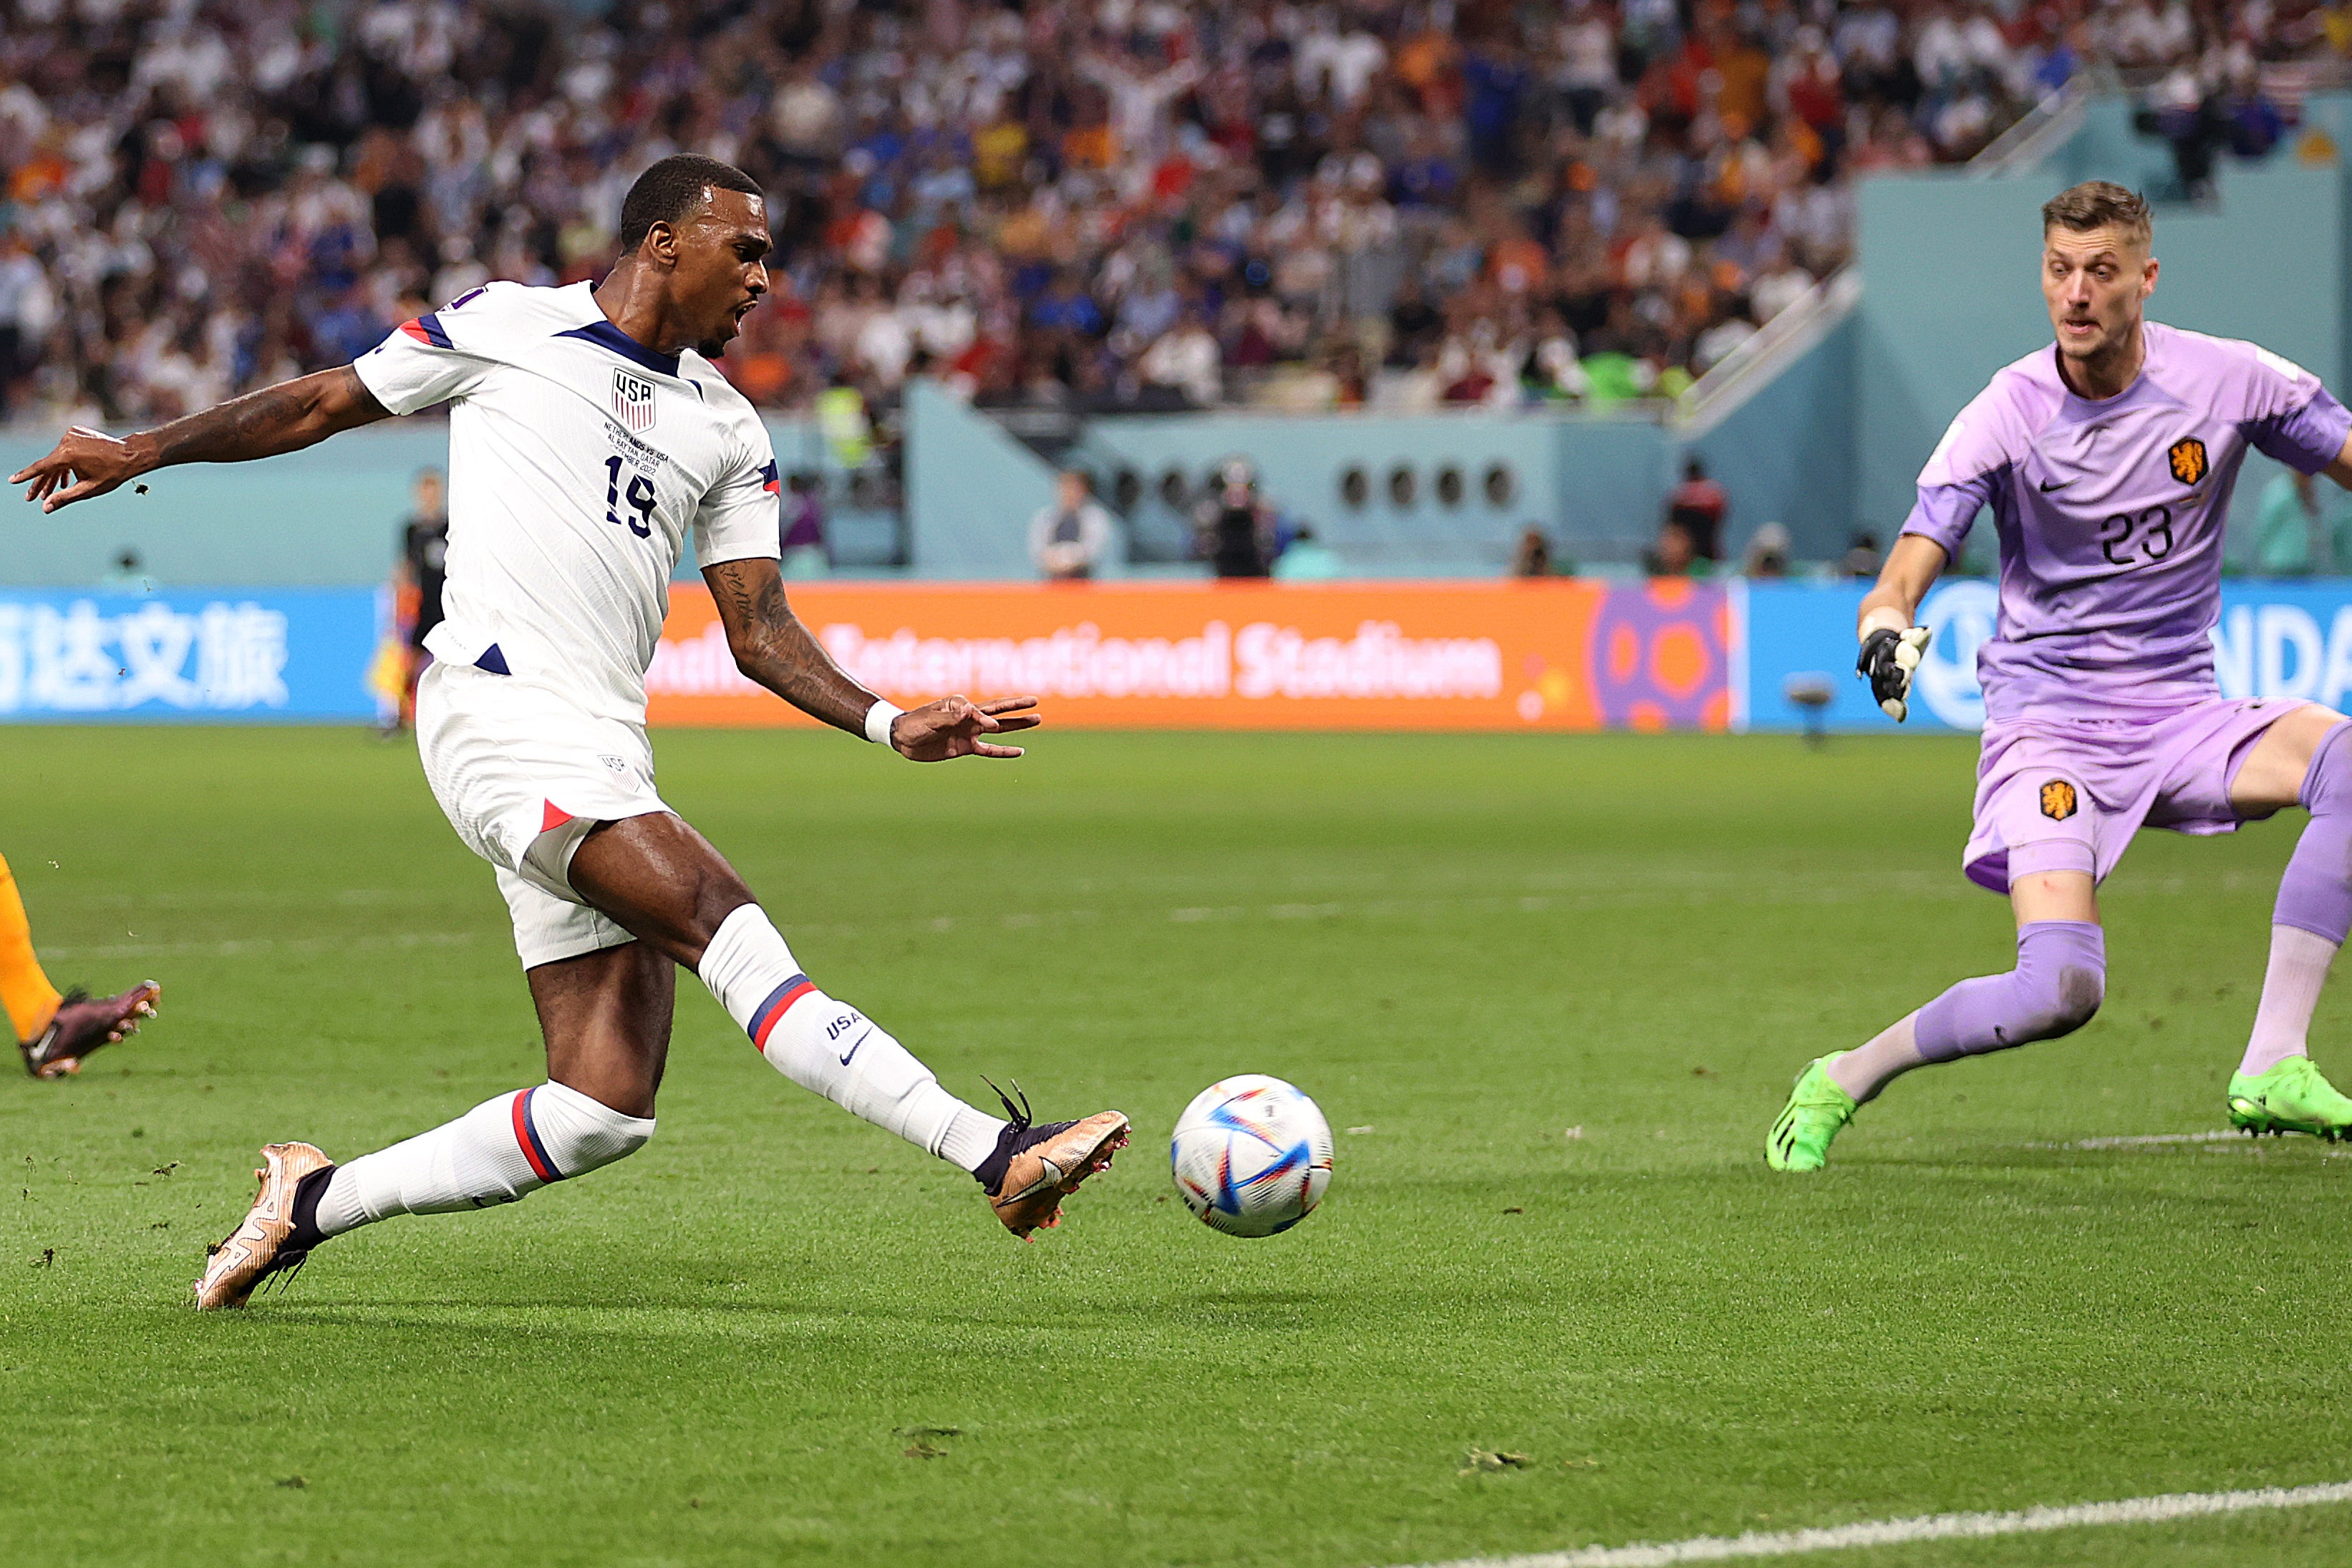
[699,903,1005,1171]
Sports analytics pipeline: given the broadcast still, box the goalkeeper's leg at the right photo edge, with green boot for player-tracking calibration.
[2227,703,2352,1140]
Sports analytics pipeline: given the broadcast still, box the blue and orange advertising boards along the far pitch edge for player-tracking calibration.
[14,579,2352,733]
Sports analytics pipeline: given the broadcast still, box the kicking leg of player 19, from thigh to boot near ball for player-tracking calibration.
[569,813,1127,1237]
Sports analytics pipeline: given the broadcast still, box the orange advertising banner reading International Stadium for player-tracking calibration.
[644,579,1733,731]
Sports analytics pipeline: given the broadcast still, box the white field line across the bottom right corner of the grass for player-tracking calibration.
[1401,1481,2352,1568]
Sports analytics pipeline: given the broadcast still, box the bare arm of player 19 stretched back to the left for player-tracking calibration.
[9,364,390,513]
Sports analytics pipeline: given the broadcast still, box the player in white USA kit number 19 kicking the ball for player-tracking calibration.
[11,155,1127,1310]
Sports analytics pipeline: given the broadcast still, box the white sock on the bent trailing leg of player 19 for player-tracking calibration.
[317,1084,654,1237]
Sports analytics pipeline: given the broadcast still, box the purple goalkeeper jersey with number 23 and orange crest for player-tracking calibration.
[1903,322,2352,722]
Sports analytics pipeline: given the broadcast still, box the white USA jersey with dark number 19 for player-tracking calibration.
[353,282,781,724]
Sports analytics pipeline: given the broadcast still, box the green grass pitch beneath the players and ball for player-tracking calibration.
[0,729,2352,1568]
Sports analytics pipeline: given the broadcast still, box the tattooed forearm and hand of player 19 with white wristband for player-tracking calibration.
[703,557,1045,762]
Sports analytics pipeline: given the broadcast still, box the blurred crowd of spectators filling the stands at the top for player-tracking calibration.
[0,0,2352,430]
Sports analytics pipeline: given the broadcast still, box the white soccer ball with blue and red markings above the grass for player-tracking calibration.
[1169,1072,1331,1237]
